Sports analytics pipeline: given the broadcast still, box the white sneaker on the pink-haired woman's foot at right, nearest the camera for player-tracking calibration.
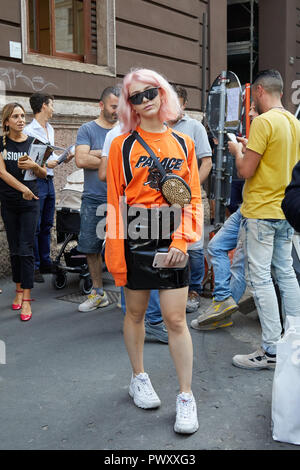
[174,393,199,434]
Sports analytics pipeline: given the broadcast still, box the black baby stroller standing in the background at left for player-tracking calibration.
[52,170,92,294]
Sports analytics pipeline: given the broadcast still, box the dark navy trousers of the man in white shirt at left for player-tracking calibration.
[34,177,55,269]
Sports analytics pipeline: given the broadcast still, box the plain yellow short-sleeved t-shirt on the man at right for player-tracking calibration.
[241,109,300,219]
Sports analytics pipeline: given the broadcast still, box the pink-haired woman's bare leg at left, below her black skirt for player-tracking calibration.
[124,287,150,375]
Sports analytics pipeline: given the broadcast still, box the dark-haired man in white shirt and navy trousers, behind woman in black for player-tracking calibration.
[24,93,69,282]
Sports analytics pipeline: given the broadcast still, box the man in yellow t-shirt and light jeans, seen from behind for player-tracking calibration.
[227,70,300,370]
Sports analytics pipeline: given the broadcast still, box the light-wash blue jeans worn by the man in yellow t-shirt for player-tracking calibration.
[241,219,300,354]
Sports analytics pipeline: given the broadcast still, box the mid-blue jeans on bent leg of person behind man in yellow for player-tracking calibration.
[207,209,246,303]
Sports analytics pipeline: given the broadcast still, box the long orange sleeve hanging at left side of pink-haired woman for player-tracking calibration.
[105,139,127,286]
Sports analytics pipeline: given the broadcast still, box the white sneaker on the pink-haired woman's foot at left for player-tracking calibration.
[129,372,161,409]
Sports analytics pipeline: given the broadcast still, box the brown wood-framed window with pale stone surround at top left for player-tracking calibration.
[20,0,116,76]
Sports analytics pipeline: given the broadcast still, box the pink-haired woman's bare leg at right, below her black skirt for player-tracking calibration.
[160,287,193,393]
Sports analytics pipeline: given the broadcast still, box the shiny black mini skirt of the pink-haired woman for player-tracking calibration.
[124,206,190,290]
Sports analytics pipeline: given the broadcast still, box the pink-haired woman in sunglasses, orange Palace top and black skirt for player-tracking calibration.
[105,69,201,434]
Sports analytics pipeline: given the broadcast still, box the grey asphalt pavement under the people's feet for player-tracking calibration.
[0,276,297,452]
